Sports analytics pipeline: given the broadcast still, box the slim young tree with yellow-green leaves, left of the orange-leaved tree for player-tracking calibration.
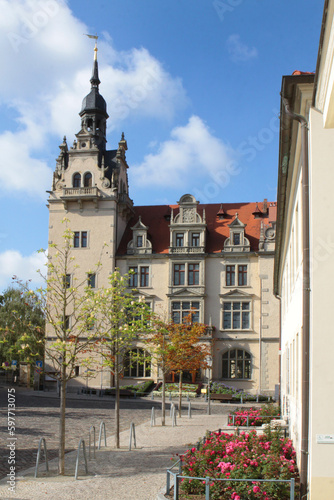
[87,269,151,448]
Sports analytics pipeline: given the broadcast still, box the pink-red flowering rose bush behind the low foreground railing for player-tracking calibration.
[180,427,298,500]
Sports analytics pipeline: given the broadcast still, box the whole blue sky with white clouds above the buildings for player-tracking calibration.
[0,0,323,291]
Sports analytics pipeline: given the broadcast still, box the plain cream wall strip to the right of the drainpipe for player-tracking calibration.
[310,105,334,498]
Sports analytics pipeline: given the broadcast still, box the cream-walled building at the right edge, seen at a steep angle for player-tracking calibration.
[275,1,334,500]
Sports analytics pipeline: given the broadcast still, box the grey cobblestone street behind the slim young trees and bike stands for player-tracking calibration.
[0,385,232,478]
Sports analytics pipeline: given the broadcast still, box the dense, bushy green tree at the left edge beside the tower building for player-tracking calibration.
[0,284,45,365]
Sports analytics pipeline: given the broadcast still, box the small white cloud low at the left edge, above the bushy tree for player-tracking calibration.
[0,250,46,290]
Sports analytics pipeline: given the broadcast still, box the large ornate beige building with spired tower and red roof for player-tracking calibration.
[45,50,279,395]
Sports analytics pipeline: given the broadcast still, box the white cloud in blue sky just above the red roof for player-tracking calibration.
[129,116,236,187]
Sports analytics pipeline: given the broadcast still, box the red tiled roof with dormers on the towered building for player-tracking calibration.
[117,202,276,255]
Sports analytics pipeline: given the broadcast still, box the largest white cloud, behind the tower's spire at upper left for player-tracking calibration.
[0,0,186,196]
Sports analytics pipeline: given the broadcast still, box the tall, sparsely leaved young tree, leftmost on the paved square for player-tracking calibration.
[24,225,99,474]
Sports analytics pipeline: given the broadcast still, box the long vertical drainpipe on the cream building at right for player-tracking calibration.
[282,97,310,500]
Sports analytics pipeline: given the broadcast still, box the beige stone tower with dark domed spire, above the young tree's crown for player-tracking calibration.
[48,45,133,286]
